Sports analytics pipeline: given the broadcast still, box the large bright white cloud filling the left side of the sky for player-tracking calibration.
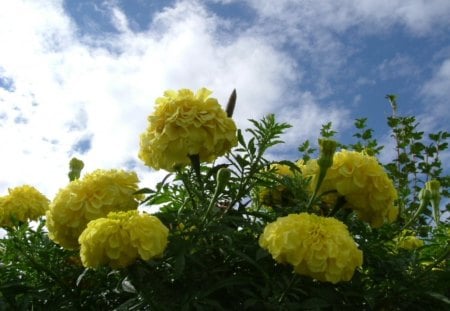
[0,0,342,200]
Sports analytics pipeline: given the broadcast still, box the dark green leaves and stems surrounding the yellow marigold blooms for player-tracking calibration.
[0,101,450,310]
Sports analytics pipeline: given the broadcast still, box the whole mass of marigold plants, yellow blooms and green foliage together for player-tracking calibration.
[0,89,450,311]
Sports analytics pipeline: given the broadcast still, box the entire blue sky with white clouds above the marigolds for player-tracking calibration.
[0,0,450,197]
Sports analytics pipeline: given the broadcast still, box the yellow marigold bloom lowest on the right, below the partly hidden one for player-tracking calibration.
[259,213,363,283]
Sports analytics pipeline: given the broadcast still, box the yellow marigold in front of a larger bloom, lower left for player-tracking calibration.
[79,210,169,268]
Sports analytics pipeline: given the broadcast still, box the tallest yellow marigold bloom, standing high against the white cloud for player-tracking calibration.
[139,88,237,171]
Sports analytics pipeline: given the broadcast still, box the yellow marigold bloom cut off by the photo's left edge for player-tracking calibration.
[0,185,50,227]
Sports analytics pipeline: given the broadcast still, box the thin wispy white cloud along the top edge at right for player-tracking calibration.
[237,0,450,35]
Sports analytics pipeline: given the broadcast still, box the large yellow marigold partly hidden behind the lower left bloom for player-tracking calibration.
[47,170,139,249]
